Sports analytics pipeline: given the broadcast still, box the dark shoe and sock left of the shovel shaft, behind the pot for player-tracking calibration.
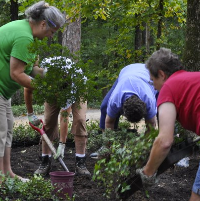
[34,155,51,176]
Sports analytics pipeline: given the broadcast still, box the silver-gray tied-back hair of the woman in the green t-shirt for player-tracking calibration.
[25,1,65,28]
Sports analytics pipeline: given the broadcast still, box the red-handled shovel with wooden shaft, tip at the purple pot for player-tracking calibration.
[29,119,69,172]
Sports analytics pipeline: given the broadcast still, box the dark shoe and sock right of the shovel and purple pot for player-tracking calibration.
[75,156,91,176]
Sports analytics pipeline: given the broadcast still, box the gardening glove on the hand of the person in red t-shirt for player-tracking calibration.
[136,167,158,188]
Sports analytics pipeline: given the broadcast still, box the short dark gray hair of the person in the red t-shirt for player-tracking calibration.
[146,48,183,78]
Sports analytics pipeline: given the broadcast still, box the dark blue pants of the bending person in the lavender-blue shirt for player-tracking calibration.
[100,79,121,129]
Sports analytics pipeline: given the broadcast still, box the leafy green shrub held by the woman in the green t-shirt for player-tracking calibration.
[27,40,100,107]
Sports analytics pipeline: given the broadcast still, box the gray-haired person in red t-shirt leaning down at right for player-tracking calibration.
[136,48,200,201]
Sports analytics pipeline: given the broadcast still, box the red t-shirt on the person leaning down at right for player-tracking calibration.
[157,70,200,135]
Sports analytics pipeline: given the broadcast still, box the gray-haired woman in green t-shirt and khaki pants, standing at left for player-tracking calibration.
[0,1,65,183]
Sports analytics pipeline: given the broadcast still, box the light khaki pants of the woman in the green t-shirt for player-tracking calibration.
[0,96,14,157]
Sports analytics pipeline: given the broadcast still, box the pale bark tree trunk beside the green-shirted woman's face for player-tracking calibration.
[62,17,81,54]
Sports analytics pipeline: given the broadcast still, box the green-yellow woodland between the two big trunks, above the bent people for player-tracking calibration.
[81,0,186,93]
